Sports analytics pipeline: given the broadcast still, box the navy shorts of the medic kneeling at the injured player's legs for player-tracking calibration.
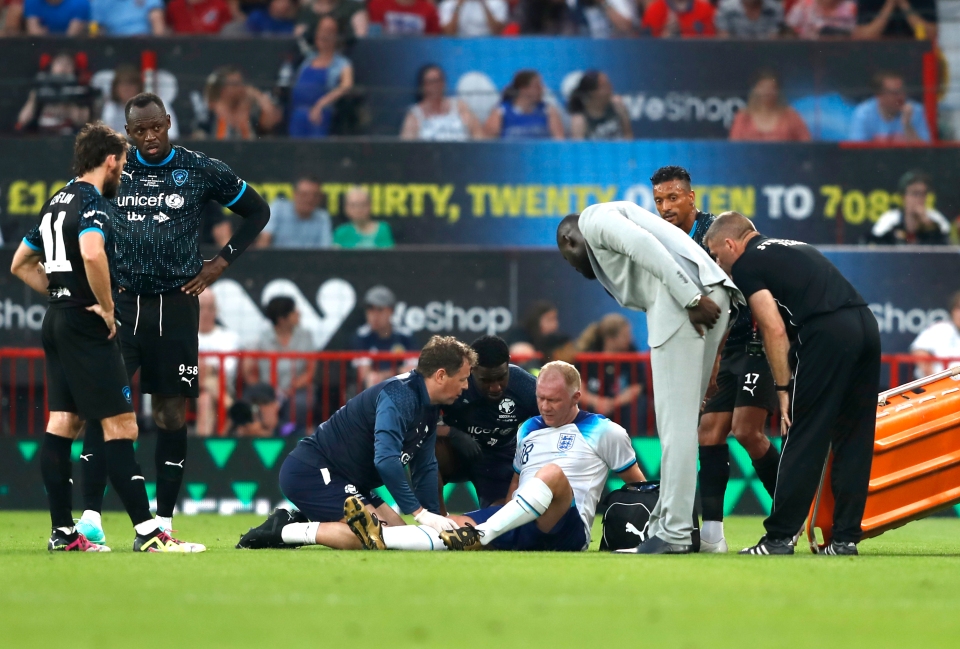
[280,455,383,523]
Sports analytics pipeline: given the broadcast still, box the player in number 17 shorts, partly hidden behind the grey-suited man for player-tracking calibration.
[650,166,780,552]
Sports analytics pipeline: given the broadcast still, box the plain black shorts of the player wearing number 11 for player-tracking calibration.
[42,307,133,420]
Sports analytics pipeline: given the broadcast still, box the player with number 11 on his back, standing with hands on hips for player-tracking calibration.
[11,123,201,552]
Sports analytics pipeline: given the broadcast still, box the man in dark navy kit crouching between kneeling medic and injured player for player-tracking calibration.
[437,336,540,507]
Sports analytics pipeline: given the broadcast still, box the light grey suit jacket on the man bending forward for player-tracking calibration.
[580,201,745,347]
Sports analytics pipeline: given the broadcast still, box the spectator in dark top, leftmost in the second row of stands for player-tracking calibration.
[16,53,96,135]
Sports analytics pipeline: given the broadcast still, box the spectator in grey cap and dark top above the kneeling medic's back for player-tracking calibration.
[350,285,419,387]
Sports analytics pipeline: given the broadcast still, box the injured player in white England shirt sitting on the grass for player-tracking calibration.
[344,361,644,552]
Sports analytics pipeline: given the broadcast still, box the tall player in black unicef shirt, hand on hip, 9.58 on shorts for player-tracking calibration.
[78,93,270,551]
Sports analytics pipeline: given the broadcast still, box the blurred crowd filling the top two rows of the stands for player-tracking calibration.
[2,0,937,143]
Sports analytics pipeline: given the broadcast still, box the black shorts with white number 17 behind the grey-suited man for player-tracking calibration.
[703,350,779,414]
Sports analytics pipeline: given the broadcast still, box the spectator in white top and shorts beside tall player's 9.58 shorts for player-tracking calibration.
[197,291,240,437]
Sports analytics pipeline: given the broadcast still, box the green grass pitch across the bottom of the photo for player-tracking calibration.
[0,512,960,649]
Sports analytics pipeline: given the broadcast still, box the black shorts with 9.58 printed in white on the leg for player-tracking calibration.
[117,290,200,398]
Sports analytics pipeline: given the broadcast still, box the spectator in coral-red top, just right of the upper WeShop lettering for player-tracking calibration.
[730,70,810,142]
